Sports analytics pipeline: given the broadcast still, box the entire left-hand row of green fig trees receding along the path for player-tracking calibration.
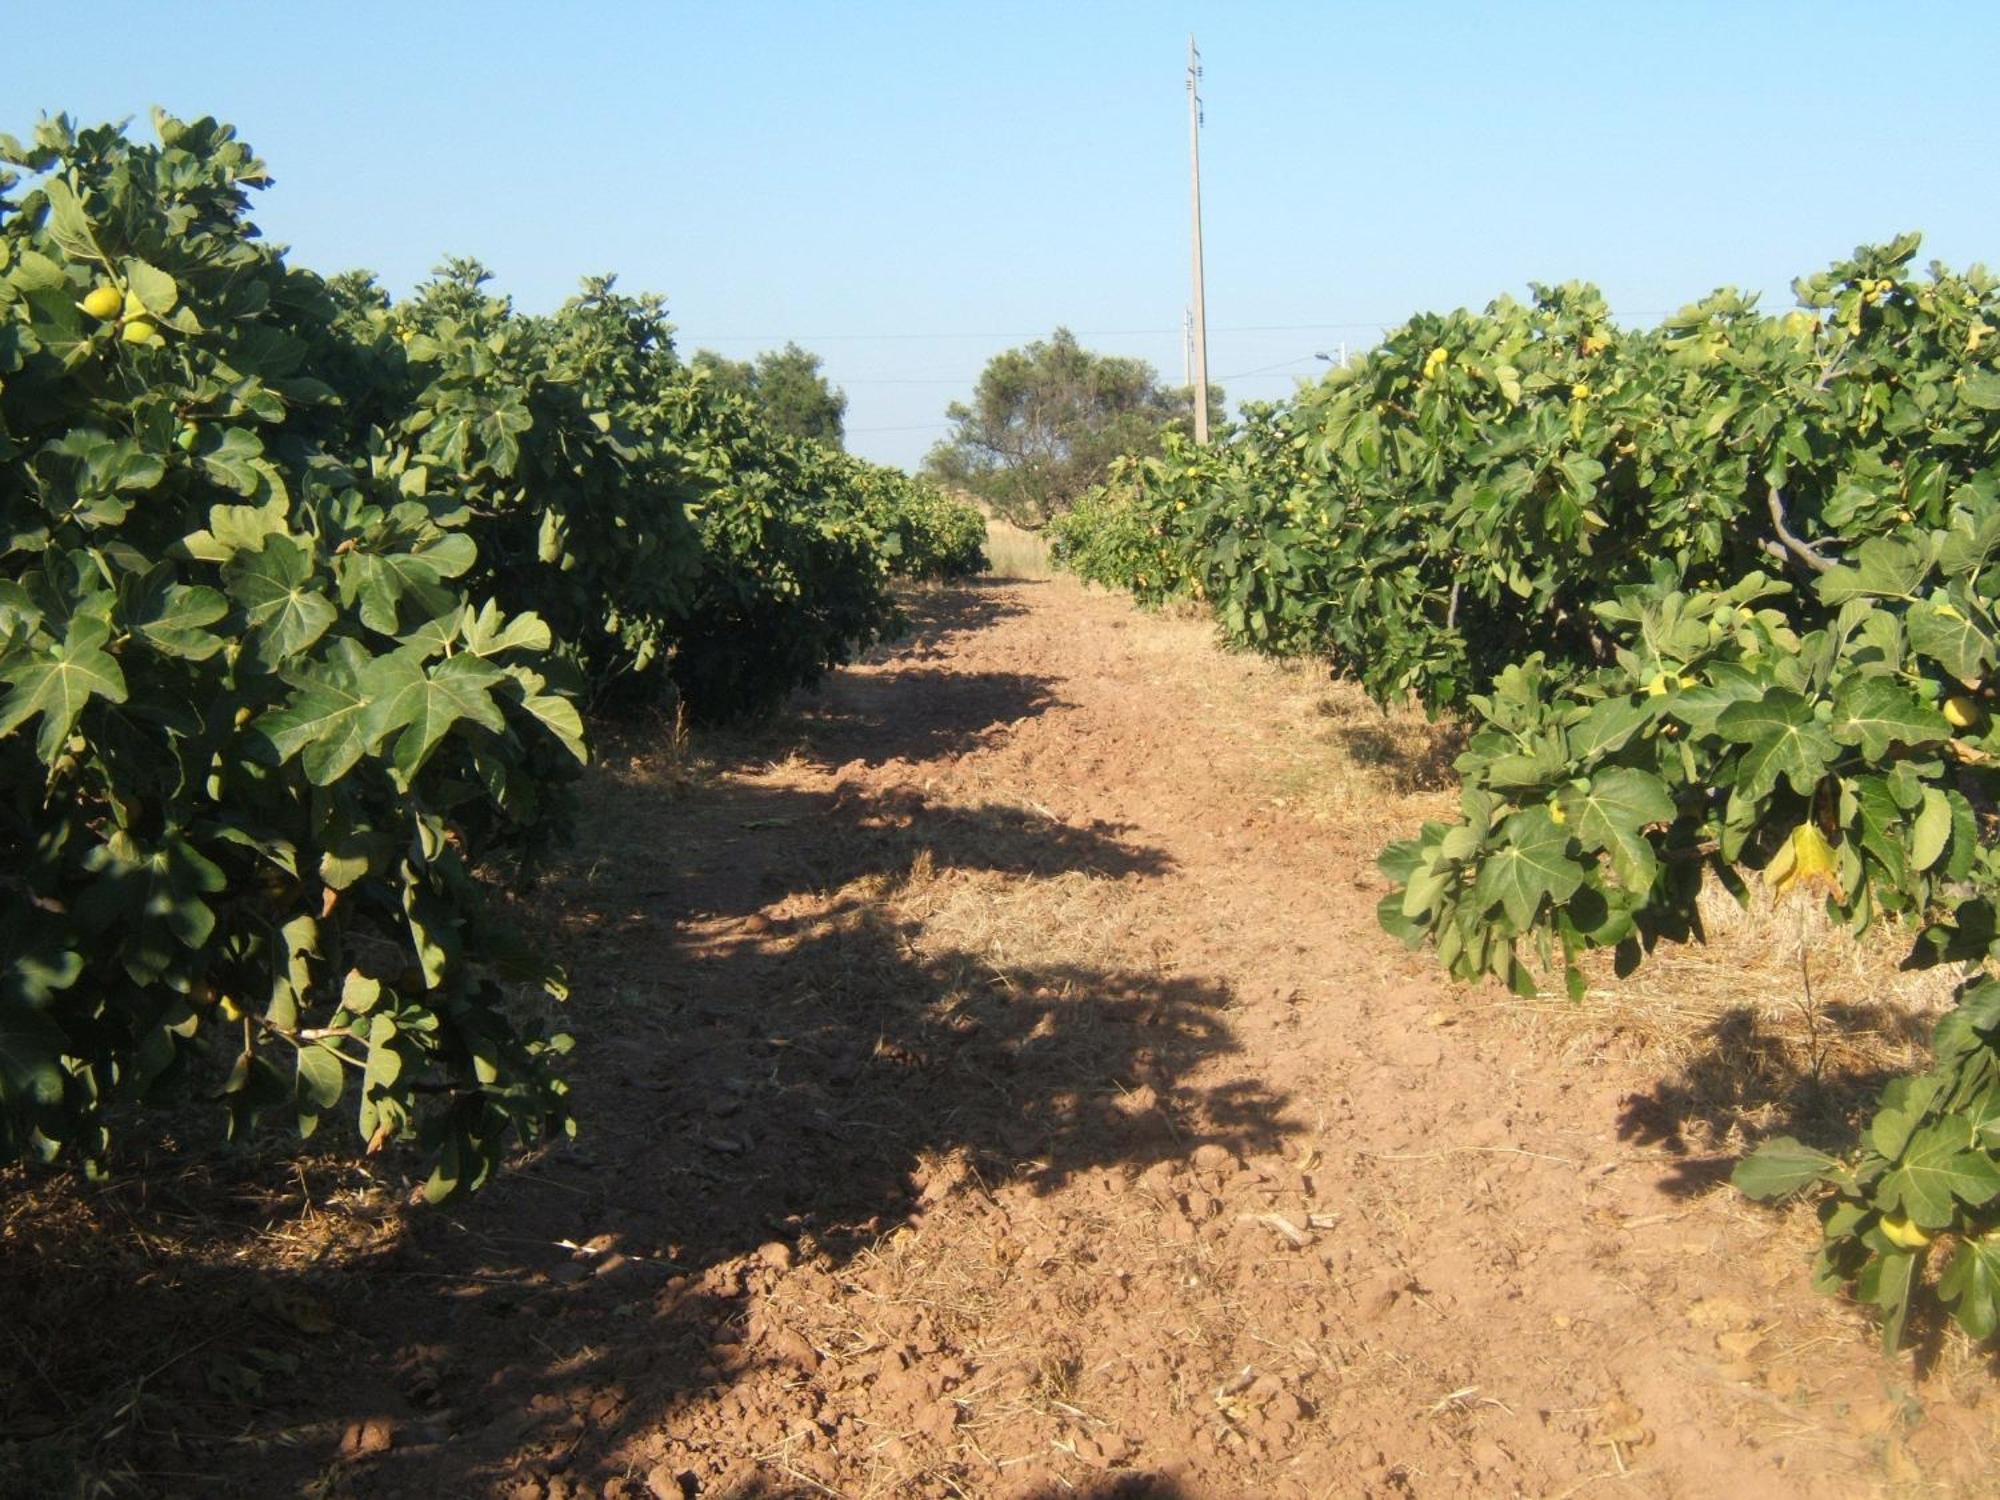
[0,118,984,1196]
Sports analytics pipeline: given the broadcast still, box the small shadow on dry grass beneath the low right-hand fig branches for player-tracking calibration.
[1618,1004,1936,1194]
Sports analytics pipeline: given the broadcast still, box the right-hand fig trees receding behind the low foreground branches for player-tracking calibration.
[1062,236,2000,708]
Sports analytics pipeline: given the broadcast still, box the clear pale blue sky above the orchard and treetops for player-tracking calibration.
[19,0,2000,464]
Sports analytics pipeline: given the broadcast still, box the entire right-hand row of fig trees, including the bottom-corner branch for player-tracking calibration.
[1056,236,2000,1346]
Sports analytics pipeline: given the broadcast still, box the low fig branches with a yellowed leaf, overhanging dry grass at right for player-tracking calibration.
[1382,516,2000,992]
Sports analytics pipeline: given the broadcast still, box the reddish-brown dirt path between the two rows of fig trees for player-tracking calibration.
[266,580,1994,1500]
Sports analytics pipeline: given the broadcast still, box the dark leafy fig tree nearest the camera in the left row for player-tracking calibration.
[0,116,584,1196]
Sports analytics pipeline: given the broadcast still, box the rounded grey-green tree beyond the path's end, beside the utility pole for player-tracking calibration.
[924,328,1222,528]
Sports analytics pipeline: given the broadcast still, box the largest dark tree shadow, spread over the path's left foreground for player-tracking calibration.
[0,724,1294,1500]
